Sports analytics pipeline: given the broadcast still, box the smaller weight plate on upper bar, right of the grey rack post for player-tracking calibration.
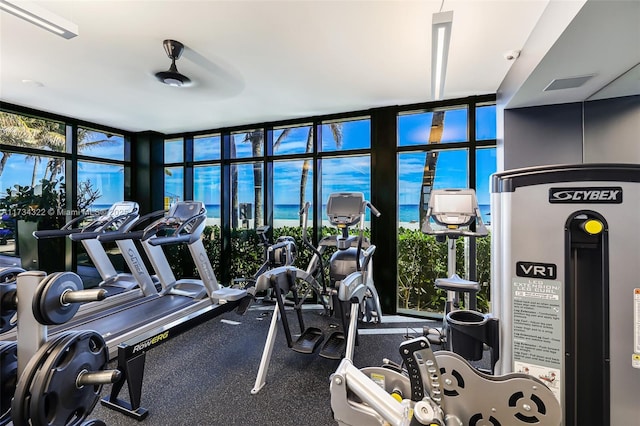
[33,272,84,325]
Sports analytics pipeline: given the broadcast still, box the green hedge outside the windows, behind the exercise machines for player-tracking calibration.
[165,226,491,312]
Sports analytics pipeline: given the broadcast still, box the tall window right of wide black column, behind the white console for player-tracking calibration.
[397,103,496,316]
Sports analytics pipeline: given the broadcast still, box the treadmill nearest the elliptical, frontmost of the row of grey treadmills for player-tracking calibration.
[13,201,247,358]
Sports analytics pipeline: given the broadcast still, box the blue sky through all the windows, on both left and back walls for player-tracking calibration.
[0,106,496,211]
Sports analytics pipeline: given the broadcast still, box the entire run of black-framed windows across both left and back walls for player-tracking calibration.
[0,96,496,308]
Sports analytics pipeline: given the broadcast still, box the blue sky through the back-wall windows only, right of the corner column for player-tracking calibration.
[154,106,496,211]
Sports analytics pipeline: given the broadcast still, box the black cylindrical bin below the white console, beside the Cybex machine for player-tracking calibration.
[447,310,488,361]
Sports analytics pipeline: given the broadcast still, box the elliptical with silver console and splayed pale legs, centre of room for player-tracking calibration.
[251,193,381,394]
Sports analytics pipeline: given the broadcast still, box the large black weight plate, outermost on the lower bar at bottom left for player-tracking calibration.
[30,331,109,425]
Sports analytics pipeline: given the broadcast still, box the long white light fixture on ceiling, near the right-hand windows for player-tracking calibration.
[431,10,453,101]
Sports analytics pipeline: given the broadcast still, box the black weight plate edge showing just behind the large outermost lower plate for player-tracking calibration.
[11,333,66,426]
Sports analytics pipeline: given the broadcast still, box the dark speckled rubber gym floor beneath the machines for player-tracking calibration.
[89,303,437,426]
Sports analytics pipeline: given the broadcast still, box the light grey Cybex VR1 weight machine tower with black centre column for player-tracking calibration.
[491,164,640,425]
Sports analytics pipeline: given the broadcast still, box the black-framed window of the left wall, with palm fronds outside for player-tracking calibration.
[0,111,129,272]
